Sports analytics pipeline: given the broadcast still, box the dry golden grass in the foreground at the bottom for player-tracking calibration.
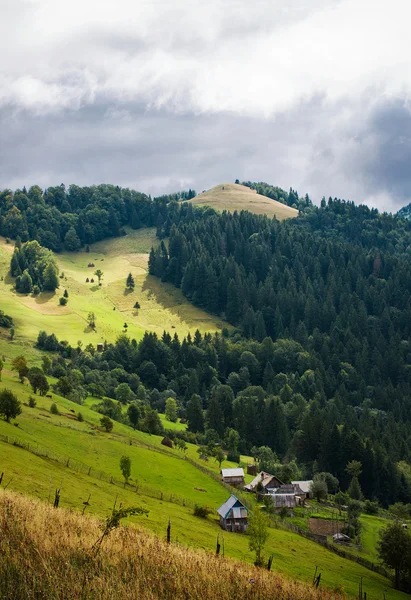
[0,491,339,600]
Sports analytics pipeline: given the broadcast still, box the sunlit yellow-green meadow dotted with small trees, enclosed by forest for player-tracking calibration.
[0,229,224,356]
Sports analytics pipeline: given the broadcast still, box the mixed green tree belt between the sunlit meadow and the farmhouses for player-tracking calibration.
[37,332,411,506]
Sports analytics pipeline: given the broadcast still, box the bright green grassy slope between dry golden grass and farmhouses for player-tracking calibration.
[0,373,405,599]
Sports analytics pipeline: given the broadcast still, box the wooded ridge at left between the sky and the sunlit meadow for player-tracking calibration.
[0,185,195,252]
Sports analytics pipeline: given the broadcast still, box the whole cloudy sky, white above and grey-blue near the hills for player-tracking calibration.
[0,0,411,211]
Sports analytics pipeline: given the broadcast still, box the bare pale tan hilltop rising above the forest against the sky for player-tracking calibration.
[190,183,298,221]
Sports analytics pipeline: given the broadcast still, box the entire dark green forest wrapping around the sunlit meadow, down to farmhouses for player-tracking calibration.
[0,182,411,506]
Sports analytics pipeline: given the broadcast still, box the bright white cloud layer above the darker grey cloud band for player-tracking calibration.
[0,0,411,118]
